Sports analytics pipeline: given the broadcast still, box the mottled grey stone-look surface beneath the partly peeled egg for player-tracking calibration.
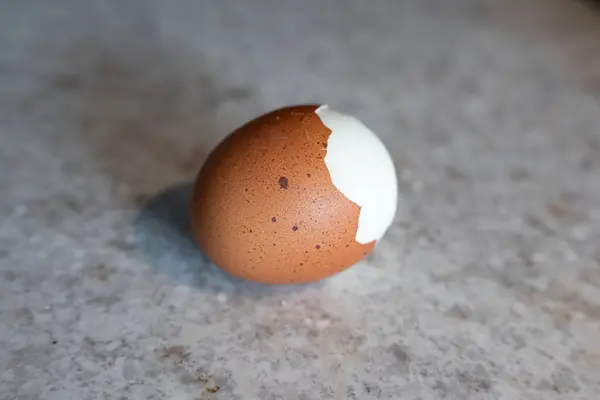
[0,0,600,400]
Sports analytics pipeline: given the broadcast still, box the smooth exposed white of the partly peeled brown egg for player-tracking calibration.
[315,105,398,244]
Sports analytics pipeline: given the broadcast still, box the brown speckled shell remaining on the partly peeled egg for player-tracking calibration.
[191,105,375,284]
